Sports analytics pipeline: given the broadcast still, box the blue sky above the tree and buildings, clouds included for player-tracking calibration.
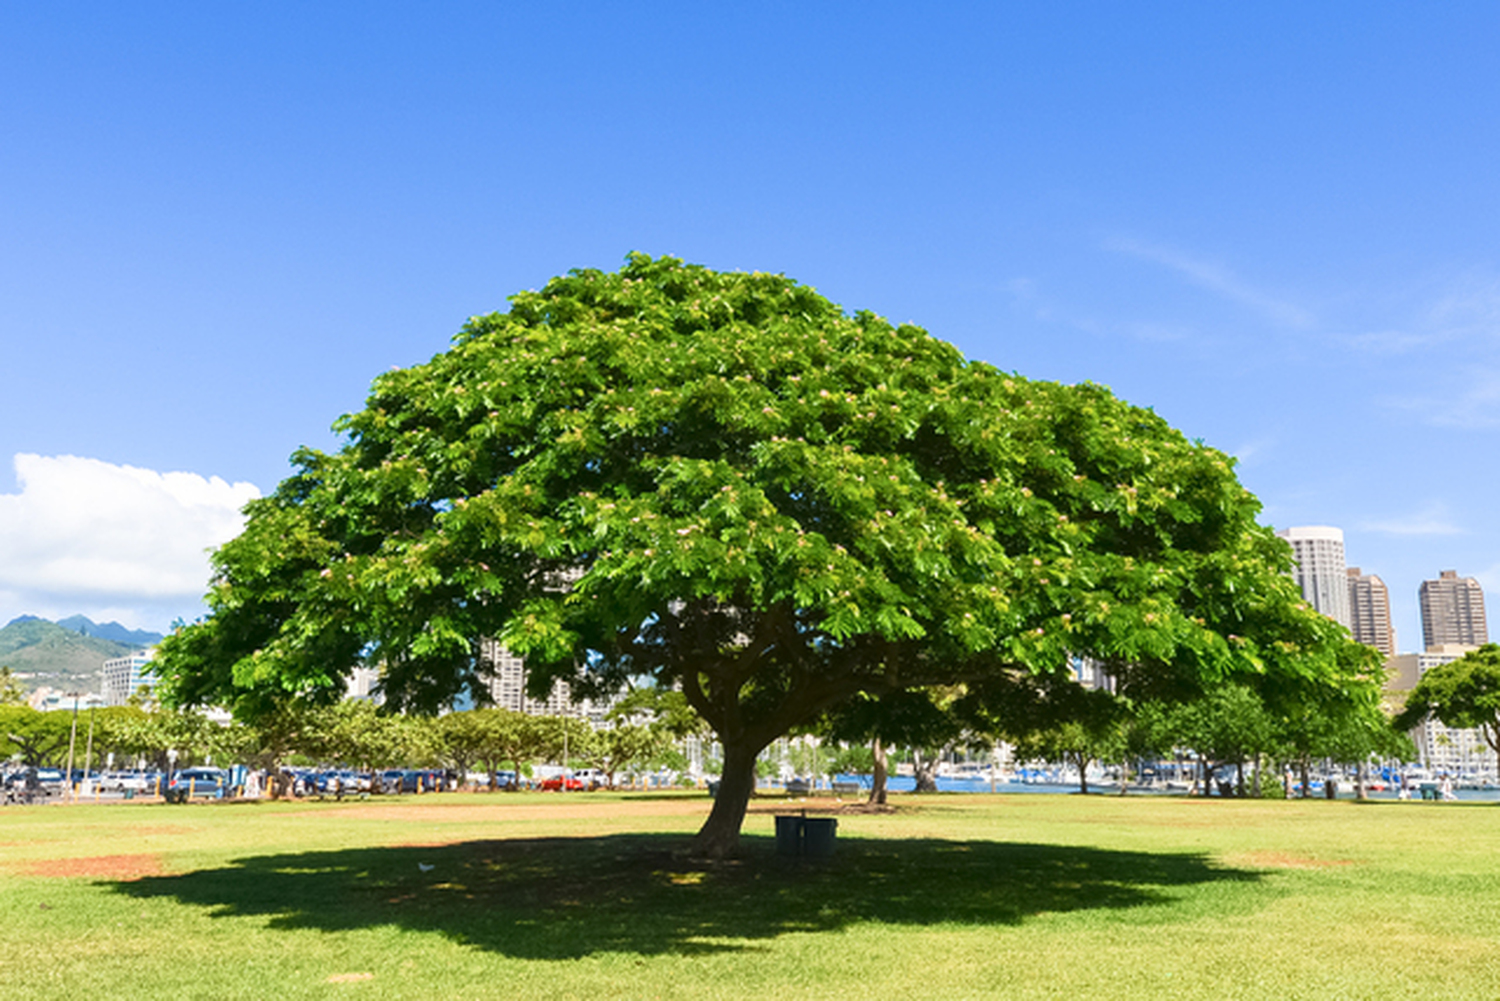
[0,3,1500,650]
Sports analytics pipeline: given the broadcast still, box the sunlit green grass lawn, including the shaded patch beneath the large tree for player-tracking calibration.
[0,794,1500,1001]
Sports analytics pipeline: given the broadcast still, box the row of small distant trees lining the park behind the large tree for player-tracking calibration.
[17,645,1500,798]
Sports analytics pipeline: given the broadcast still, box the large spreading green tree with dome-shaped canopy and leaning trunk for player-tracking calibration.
[159,255,1368,854]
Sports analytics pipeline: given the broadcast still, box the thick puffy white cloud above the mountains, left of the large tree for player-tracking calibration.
[0,453,260,624]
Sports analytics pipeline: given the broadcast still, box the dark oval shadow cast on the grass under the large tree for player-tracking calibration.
[113,834,1260,959]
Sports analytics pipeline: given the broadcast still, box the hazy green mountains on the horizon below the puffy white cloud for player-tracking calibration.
[0,615,162,690]
